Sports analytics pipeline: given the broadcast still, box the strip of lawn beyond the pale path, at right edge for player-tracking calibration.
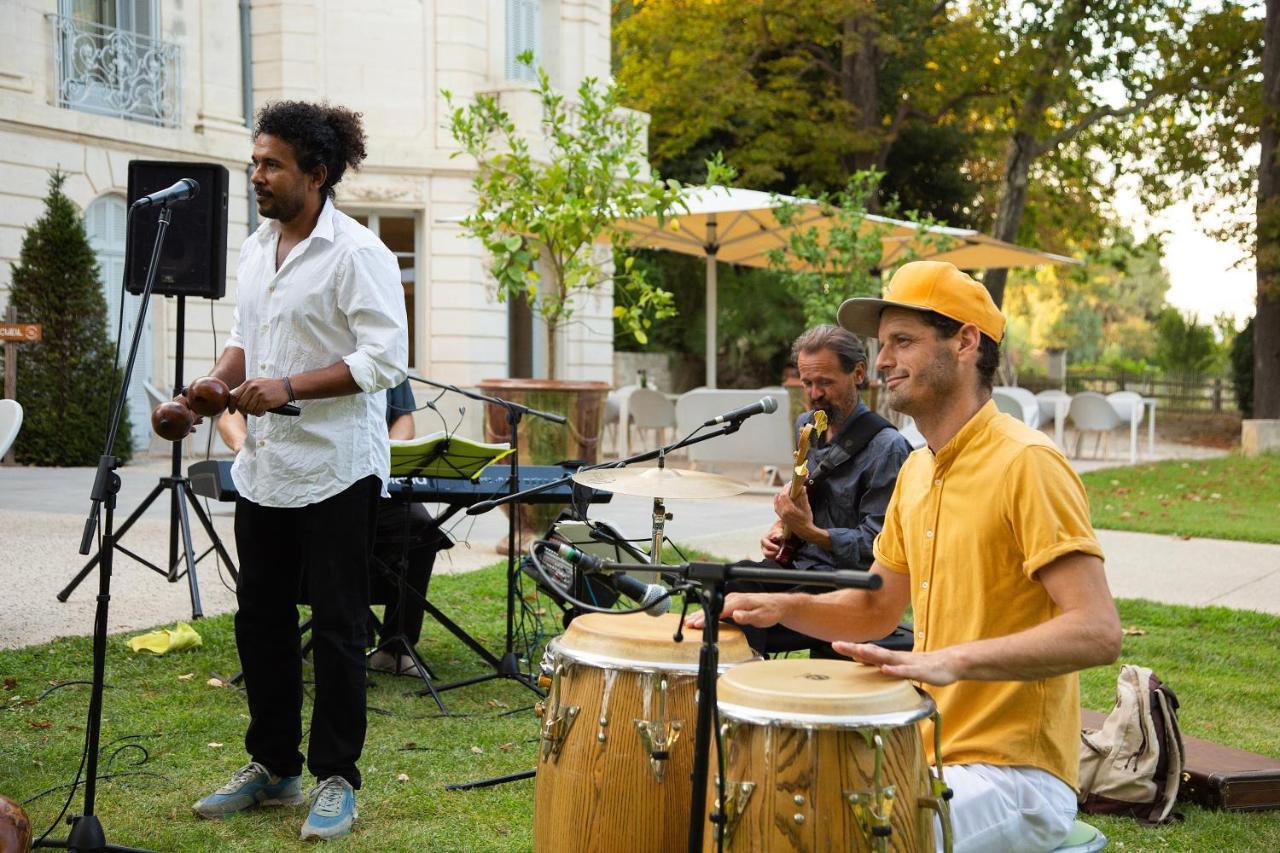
[1080,453,1280,543]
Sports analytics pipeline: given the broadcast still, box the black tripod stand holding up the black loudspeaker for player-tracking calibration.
[58,295,239,619]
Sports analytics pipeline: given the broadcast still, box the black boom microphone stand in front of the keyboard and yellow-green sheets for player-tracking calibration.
[408,375,564,698]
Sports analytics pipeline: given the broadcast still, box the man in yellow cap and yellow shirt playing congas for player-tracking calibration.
[706,261,1121,850]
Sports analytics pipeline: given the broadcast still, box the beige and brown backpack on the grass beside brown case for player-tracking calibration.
[1079,665,1185,824]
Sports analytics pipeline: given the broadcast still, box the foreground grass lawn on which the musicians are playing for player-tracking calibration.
[0,567,1280,852]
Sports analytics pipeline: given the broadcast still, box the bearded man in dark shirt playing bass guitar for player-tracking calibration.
[691,325,911,656]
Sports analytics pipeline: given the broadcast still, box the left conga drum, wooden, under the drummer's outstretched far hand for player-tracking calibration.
[534,613,755,853]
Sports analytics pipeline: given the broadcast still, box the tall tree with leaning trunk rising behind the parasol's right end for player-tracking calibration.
[977,0,1256,304]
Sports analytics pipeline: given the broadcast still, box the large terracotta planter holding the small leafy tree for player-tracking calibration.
[479,379,609,537]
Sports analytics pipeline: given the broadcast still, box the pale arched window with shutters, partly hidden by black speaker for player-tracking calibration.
[84,195,152,450]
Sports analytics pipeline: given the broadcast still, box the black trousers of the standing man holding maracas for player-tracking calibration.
[236,476,381,788]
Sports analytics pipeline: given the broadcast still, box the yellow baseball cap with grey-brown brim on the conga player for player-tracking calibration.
[836,261,1005,343]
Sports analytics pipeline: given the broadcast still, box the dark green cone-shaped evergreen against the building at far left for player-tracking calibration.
[9,172,133,466]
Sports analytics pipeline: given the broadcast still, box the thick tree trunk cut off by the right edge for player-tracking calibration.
[1253,0,1280,418]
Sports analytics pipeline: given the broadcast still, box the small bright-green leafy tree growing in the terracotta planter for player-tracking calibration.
[444,54,680,379]
